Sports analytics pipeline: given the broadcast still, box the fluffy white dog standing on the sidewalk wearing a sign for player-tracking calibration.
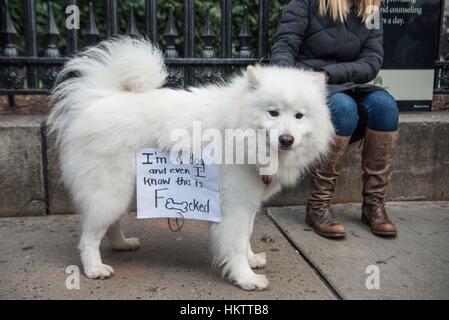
[49,38,334,290]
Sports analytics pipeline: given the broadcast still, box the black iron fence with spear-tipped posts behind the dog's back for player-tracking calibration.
[0,0,269,105]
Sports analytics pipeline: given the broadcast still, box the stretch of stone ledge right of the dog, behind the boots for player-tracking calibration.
[269,112,449,206]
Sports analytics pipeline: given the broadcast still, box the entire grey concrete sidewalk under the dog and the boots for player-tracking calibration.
[0,202,449,299]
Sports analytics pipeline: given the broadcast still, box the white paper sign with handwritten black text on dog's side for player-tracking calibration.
[136,149,220,222]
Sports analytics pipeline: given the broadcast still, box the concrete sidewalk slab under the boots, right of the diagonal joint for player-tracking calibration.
[269,202,449,299]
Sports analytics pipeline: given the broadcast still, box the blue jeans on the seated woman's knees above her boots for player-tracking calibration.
[329,90,399,137]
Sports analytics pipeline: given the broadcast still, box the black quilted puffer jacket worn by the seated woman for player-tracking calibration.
[271,0,384,94]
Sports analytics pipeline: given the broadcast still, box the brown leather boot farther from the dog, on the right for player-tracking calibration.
[362,129,398,236]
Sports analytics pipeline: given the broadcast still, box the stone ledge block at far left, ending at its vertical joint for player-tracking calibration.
[0,116,47,217]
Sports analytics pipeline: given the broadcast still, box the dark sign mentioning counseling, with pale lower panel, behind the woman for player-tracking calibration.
[374,0,443,111]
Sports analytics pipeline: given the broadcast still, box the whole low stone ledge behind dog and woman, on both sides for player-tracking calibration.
[0,112,449,216]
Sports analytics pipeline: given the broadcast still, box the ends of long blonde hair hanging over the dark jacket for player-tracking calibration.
[319,0,382,22]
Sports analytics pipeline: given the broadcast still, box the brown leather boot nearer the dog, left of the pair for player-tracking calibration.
[306,136,351,238]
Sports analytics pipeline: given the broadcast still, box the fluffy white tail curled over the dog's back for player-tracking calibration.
[48,37,167,138]
